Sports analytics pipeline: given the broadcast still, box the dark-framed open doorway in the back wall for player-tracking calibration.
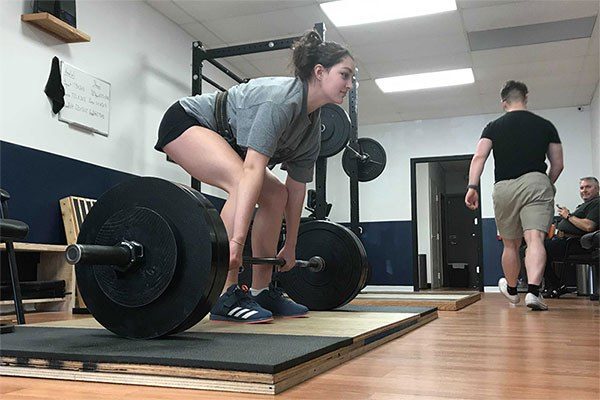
[411,154,483,291]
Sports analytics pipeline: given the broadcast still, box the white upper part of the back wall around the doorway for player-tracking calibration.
[328,107,597,221]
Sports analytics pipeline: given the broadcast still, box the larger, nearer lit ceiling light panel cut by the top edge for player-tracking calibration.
[321,0,456,26]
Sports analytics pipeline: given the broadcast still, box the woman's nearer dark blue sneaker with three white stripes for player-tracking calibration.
[210,285,273,324]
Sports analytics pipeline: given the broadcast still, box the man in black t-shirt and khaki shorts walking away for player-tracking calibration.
[465,81,563,310]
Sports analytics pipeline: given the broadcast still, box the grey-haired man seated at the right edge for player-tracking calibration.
[544,176,599,297]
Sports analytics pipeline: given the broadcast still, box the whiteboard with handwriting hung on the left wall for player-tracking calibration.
[58,61,110,136]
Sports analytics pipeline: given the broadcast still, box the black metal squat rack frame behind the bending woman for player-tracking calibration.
[192,22,361,236]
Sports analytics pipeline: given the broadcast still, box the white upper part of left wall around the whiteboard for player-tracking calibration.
[0,0,239,198]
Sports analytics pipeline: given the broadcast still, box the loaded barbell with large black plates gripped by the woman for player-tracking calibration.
[65,177,369,339]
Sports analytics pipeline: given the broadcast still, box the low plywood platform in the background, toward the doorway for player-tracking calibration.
[350,291,481,311]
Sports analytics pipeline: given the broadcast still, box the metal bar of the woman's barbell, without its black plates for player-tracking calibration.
[65,241,325,272]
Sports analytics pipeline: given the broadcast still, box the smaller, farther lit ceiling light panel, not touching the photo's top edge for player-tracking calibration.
[375,68,475,93]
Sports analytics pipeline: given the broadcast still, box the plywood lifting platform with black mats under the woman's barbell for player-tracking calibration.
[0,307,437,394]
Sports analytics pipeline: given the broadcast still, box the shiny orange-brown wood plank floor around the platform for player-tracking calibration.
[0,293,600,400]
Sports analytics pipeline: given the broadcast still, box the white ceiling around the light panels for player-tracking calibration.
[146,0,599,124]
